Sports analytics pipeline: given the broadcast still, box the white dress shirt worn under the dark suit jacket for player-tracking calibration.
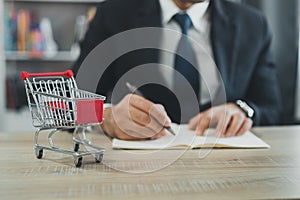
[159,0,219,104]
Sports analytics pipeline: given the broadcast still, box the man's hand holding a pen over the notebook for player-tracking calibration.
[102,94,171,140]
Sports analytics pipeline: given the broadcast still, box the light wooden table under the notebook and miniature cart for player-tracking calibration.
[0,126,300,199]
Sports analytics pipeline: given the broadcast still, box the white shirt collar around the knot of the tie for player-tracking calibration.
[159,0,210,31]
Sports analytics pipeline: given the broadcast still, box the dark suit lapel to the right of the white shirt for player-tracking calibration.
[211,0,237,88]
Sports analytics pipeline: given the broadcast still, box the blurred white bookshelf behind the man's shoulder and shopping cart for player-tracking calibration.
[0,0,103,132]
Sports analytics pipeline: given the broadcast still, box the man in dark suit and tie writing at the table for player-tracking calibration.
[73,0,280,139]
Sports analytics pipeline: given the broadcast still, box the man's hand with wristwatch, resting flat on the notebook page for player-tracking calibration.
[189,103,253,137]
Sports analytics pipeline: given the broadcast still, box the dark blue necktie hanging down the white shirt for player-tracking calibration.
[174,14,200,123]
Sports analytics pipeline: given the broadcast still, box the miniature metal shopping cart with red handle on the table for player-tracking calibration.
[21,70,105,167]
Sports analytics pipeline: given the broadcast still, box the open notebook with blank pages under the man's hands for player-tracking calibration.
[112,124,270,149]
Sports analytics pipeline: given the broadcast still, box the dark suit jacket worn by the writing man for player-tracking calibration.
[73,0,280,125]
